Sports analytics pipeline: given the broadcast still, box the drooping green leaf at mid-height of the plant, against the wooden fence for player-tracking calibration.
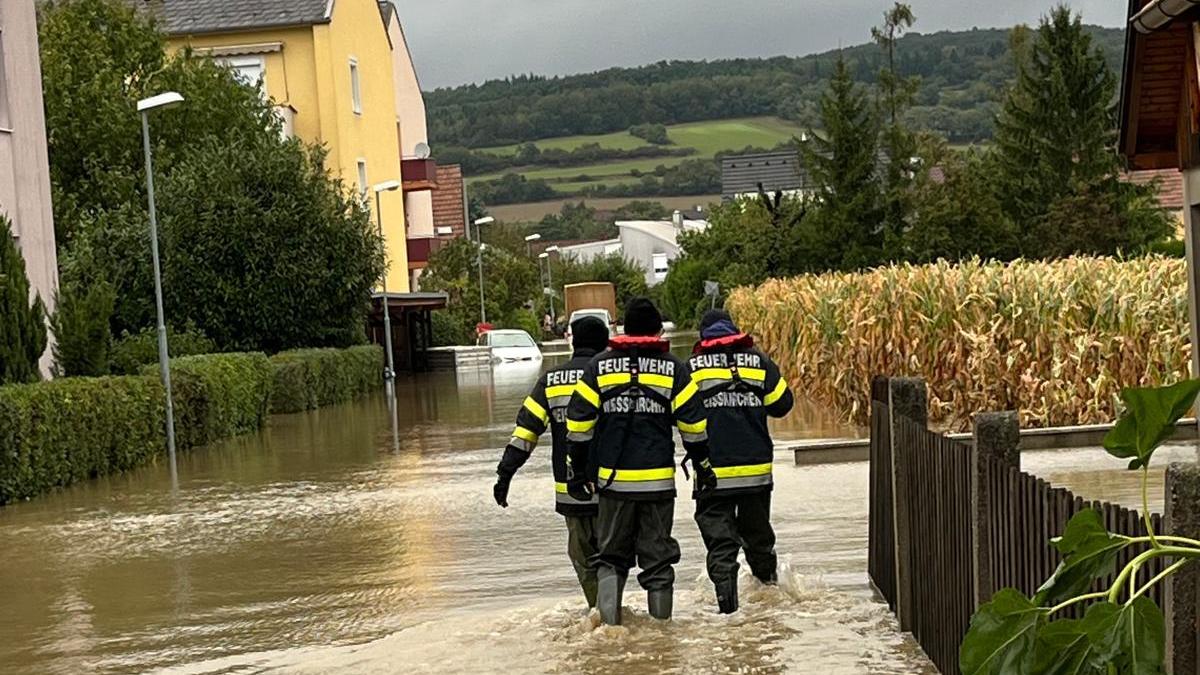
[1033,509,1129,605]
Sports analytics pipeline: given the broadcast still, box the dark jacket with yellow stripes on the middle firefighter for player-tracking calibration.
[566,336,708,500]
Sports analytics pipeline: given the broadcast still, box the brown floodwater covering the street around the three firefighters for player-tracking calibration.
[0,353,930,674]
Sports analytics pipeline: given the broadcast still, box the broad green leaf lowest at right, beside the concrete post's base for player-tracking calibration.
[1084,596,1166,675]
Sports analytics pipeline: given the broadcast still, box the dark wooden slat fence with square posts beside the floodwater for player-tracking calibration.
[868,378,1180,674]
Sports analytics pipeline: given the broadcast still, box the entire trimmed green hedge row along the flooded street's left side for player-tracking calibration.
[0,347,383,504]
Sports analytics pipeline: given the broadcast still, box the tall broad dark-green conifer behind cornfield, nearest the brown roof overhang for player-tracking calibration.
[995,5,1169,258]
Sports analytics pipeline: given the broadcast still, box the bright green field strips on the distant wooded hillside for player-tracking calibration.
[468,118,800,192]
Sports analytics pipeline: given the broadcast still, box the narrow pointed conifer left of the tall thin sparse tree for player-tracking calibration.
[800,59,883,269]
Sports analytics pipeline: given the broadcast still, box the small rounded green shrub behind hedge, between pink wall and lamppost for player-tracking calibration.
[50,280,116,377]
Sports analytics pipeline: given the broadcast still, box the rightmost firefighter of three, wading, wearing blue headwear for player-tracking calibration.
[689,310,793,614]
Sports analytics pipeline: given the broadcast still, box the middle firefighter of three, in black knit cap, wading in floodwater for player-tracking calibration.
[566,298,716,625]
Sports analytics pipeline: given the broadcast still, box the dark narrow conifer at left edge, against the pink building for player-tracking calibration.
[0,214,46,384]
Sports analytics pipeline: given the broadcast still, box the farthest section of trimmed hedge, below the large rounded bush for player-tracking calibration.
[271,345,383,413]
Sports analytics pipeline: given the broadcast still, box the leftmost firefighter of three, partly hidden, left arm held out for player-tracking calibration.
[492,317,608,608]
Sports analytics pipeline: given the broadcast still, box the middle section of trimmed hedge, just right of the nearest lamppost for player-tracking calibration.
[159,352,274,447]
